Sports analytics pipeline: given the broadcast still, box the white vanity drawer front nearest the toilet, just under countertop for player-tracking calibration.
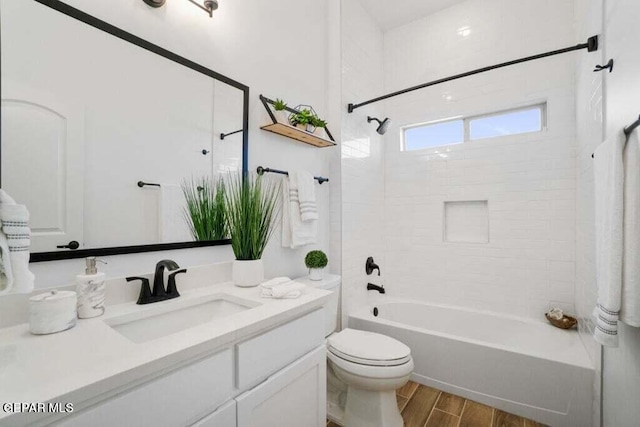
[236,309,325,390]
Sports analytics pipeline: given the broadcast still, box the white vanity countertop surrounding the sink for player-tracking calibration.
[0,283,331,424]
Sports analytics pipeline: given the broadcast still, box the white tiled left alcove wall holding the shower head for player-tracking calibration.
[342,0,386,326]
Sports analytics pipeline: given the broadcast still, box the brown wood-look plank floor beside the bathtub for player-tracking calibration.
[327,381,544,427]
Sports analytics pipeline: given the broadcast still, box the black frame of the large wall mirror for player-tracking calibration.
[0,0,249,262]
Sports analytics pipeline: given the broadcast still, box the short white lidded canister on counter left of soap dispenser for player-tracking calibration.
[29,291,78,335]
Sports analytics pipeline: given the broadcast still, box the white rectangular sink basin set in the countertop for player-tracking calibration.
[105,294,260,343]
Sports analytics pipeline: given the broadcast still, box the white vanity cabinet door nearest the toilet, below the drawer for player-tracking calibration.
[236,345,327,427]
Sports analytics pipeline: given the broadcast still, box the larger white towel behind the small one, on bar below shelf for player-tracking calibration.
[282,172,318,249]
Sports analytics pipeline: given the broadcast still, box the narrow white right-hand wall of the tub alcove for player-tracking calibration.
[575,0,606,425]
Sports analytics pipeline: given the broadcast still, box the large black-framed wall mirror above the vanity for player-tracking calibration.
[0,0,249,261]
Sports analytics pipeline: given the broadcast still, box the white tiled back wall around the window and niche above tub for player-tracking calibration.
[384,0,584,319]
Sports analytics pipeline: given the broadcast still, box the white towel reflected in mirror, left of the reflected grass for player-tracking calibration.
[158,184,193,243]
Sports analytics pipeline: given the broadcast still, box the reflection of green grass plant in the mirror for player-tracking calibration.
[181,177,228,241]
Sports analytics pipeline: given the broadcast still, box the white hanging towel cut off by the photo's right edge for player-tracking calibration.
[620,132,640,327]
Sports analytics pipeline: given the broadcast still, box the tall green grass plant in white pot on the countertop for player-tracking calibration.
[224,173,282,287]
